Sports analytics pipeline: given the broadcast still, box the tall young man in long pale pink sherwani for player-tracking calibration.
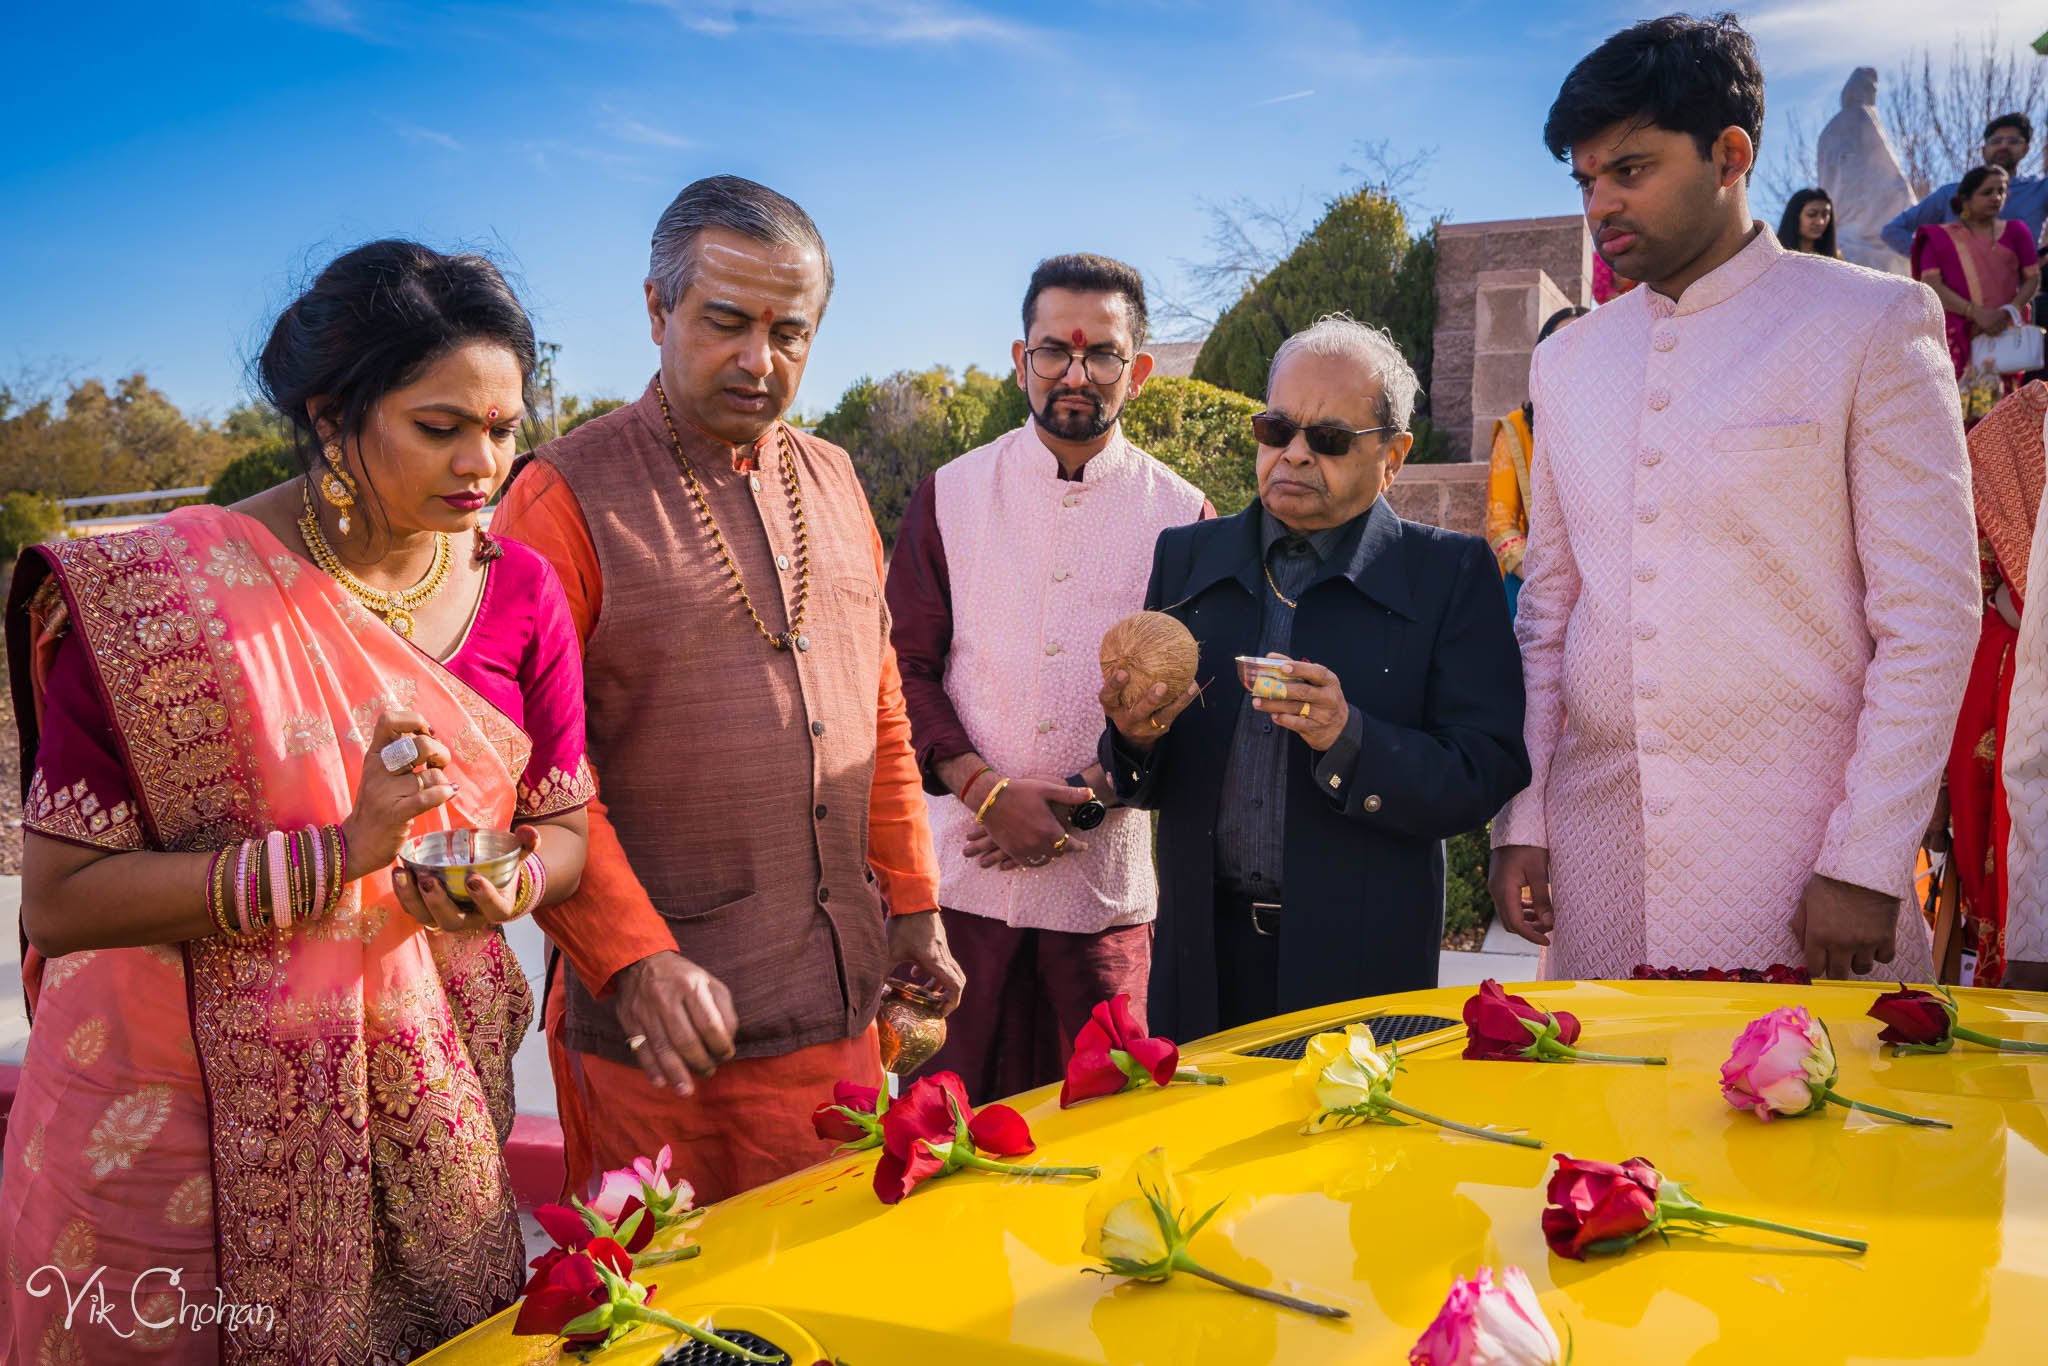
[1489,16,1978,981]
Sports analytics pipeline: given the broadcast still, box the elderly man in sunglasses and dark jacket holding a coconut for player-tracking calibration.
[1102,315,1530,1038]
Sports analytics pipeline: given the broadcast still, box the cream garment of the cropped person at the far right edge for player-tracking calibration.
[1993,401,2048,966]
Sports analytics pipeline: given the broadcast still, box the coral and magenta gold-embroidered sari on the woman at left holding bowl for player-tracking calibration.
[0,508,592,1366]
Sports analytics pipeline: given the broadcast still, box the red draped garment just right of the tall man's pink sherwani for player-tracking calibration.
[1948,608,2019,981]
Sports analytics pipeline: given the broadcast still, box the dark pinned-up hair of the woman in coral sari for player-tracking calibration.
[256,240,537,540]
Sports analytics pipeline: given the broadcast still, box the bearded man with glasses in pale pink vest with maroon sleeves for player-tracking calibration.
[889,256,1214,1098]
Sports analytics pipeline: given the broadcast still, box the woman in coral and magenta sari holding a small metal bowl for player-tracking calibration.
[0,242,594,1364]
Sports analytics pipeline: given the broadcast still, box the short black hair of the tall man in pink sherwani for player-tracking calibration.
[1542,14,1763,162]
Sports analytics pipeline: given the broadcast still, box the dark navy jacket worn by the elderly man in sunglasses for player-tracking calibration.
[1102,498,1530,1040]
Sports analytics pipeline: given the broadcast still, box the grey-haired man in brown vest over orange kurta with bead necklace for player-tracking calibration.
[496,176,961,1202]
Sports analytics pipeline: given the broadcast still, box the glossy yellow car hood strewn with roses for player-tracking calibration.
[426,981,2048,1366]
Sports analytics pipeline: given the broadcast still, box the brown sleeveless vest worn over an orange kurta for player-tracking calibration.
[535,385,889,1061]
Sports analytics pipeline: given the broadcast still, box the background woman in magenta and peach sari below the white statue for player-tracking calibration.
[1913,166,2042,422]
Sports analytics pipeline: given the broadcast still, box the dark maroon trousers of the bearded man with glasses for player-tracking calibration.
[920,909,1153,1100]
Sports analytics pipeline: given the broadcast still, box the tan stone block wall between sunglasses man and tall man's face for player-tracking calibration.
[1430,213,1593,461]
